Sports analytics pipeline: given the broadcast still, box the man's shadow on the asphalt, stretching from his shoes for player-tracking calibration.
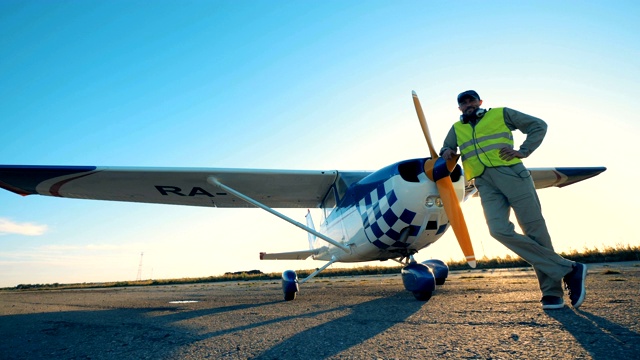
[545,308,640,360]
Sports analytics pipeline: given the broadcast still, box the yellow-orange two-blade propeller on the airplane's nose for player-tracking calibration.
[411,91,476,268]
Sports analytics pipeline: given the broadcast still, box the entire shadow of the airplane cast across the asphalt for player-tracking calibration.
[0,291,426,360]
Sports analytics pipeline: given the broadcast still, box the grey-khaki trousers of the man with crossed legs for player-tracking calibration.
[475,164,574,297]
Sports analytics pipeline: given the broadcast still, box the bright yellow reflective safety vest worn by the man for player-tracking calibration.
[453,108,522,180]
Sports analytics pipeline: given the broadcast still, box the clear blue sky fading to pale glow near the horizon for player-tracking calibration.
[0,0,640,286]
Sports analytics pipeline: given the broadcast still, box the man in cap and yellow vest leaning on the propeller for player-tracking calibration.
[440,90,587,309]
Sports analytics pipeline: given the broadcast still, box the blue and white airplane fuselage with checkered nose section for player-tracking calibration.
[313,159,464,262]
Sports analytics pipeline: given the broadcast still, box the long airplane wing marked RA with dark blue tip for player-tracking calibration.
[0,165,369,208]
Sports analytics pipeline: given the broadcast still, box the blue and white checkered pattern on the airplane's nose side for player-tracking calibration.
[357,180,421,250]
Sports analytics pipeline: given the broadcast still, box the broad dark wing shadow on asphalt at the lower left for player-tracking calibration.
[0,301,282,360]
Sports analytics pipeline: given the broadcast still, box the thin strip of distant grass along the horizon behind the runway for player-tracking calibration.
[0,245,640,290]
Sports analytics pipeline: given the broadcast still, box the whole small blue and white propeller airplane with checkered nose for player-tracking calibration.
[0,91,606,301]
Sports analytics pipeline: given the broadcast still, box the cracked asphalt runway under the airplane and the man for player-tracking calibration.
[0,262,640,359]
